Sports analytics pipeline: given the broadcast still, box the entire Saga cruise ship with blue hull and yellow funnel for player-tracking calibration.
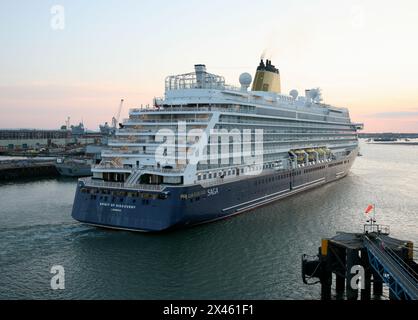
[72,59,362,232]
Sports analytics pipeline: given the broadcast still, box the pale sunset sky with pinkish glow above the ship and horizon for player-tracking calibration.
[0,0,418,132]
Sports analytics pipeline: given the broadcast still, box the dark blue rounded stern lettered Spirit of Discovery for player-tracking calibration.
[72,180,182,232]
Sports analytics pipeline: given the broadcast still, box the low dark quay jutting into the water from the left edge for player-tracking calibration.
[0,159,58,181]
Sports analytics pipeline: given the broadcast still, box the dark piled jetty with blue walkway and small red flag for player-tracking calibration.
[302,223,418,300]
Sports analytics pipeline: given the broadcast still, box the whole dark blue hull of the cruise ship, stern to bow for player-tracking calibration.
[72,150,357,232]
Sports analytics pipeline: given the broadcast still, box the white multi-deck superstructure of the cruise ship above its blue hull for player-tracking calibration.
[92,61,359,185]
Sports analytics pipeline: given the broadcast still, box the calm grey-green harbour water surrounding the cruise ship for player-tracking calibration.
[0,142,418,299]
